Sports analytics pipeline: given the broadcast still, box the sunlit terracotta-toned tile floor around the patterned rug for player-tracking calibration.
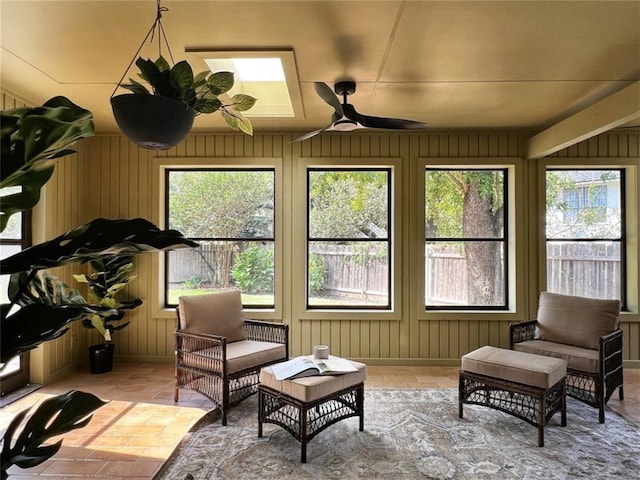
[0,363,640,480]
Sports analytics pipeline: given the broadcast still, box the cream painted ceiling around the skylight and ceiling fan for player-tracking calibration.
[0,0,640,137]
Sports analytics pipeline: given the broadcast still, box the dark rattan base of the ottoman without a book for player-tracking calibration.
[458,370,567,447]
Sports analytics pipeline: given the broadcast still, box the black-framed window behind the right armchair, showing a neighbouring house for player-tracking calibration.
[546,168,625,304]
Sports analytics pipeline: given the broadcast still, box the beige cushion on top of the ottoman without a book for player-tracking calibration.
[462,346,567,390]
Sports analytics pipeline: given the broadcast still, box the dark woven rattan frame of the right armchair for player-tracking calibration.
[509,320,624,423]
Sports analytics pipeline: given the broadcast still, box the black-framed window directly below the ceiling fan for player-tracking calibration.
[306,167,392,310]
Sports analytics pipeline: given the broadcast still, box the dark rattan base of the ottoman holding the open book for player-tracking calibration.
[258,382,364,463]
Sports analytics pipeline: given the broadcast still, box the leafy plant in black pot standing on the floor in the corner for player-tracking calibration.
[73,255,142,373]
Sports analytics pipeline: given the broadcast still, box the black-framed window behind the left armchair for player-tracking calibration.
[165,168,275,308]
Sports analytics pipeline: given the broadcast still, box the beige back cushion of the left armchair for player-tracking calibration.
[178,290,246,342]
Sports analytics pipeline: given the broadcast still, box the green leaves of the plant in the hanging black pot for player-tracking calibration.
[120,56,256,135]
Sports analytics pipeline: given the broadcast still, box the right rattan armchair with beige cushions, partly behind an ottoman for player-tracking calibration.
[510,292,624,423]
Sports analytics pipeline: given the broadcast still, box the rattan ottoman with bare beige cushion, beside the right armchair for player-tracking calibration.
[458,346,567,447]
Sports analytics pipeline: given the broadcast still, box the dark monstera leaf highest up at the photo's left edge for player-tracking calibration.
[0,97,94,232]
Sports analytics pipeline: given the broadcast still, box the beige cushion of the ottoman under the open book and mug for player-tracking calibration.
[260,360,367,402]
